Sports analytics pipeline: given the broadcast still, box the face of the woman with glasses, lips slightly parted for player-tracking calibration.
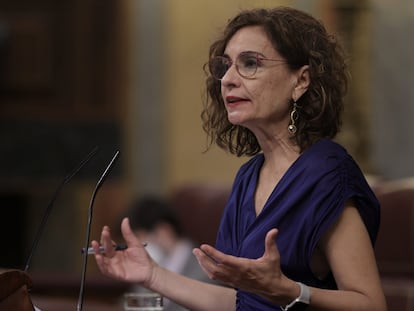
[221,26,298,136]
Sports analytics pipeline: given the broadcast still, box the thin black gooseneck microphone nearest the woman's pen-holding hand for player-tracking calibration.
[77,151,119,311]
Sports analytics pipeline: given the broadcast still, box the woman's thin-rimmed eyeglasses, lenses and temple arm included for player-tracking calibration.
[209,52,286,80]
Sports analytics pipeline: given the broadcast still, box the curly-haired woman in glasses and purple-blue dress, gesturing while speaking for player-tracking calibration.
[92,8,386,311]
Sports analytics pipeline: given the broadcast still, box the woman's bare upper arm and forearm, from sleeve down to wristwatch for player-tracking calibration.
[310,202,387,311]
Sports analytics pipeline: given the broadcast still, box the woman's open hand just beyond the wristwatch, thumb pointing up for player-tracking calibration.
[193,229,294,302]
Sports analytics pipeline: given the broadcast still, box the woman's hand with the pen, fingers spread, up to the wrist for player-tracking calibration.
[92,218,157,287]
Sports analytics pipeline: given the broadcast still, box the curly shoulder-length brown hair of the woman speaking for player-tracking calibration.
[201,7,348,156]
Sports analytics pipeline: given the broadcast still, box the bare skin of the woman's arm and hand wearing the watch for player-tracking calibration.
[194,203,387,311]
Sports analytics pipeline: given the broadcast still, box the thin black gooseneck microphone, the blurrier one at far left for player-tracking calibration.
[24,147,98,272]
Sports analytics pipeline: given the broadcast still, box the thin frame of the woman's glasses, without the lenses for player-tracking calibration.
[208,52,288,81]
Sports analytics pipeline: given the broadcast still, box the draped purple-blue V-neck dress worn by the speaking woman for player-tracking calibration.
[216,139,380,311]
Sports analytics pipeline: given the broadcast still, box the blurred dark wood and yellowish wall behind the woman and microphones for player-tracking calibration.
[0,0,414,308]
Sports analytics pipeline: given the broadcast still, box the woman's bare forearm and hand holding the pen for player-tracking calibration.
[92,219,236,311]
